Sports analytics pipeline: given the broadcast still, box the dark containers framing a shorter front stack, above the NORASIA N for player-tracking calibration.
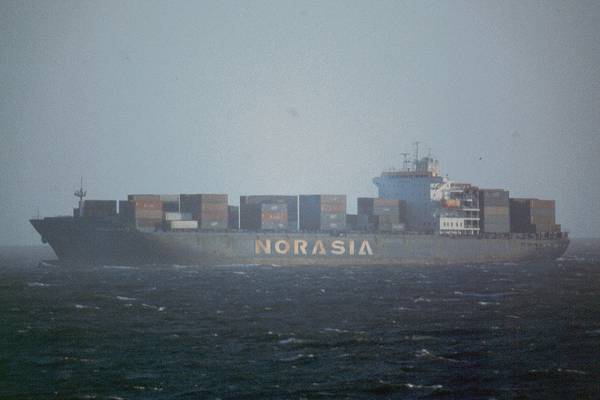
[240,195,298,231]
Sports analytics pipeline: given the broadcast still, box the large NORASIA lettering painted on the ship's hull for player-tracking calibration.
[254,239,373,256]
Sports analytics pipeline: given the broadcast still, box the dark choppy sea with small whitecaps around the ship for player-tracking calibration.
[0,239,600,400]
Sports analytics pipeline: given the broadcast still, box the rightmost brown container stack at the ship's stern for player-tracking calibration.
[510,198,560,233]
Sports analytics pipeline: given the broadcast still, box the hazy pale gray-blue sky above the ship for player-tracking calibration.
[0,0,600,245]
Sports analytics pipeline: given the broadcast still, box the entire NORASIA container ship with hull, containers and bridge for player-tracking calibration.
[30,151,569,266]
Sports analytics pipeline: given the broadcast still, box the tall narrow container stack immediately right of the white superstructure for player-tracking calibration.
[479,189,510,233]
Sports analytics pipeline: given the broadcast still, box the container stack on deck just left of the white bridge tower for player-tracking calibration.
[358,197,406,232]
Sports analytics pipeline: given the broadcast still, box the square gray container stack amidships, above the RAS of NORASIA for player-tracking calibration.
[300,194,346,231]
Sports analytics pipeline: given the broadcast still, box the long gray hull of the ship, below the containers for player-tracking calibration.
[31,217,569,265]
